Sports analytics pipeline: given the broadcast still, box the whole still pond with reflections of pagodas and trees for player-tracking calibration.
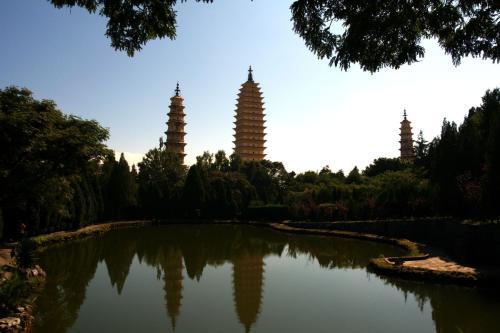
[34,225,500,333]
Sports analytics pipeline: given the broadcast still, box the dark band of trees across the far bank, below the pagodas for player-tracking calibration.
[0,87,500,237]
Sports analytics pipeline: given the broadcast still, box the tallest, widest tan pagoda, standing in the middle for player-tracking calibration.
[233,66,266,161]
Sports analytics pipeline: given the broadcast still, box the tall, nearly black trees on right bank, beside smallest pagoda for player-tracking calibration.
[420,89,500,216]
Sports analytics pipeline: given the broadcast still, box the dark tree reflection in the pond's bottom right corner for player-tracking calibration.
[376,277,500,332]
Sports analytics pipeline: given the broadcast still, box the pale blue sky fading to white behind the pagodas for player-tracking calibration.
[0,0,500,171]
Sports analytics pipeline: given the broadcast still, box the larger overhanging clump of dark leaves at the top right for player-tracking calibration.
[291,0,500,72]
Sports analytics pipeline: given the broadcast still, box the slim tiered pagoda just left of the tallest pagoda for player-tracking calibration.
[165,83,186,164]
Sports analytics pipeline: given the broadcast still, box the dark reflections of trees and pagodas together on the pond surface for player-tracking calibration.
[34,225,500,333]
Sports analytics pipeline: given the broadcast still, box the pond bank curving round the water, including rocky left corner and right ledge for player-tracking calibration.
[0,219,500,332]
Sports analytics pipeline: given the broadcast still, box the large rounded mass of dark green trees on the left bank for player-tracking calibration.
[0,87,135,237]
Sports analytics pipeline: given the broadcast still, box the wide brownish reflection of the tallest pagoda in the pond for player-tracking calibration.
[233,254,264,332]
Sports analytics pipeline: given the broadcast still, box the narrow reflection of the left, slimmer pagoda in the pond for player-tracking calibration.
[162,249,184,330]
